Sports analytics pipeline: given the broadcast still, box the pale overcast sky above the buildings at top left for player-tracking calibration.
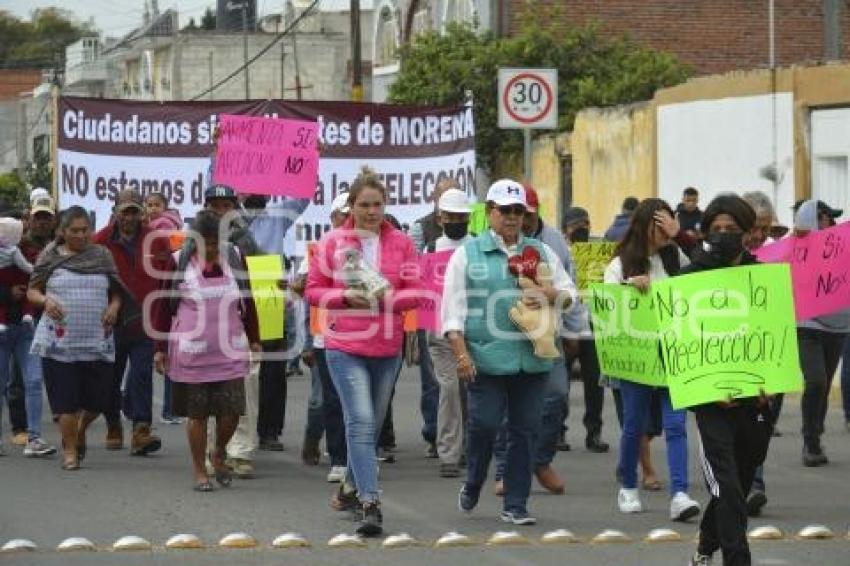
[0,0,255,36]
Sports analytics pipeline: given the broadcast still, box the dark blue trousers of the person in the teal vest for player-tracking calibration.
[466,373,549,513]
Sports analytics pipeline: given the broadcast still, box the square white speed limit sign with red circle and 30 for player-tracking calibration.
[498,69,558,129]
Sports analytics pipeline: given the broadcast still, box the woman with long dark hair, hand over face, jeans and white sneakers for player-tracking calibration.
[605,198,700,521]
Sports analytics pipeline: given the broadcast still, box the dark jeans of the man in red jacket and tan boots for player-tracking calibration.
[104,333,154,424]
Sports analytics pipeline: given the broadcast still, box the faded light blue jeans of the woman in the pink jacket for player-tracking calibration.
[325,350,401,503]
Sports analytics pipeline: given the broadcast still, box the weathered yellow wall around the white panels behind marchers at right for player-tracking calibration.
[533,64,850,234]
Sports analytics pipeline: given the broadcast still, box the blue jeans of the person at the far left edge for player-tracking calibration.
[0,323,43,440]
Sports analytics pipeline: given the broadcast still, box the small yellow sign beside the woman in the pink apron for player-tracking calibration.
[245,255,285,340]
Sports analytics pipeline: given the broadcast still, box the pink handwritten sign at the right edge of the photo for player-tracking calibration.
[754,222,850,321]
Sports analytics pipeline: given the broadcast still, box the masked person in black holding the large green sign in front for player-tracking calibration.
[680,195,773,566]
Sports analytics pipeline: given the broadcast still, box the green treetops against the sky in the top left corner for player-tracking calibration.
[0,8,94,69]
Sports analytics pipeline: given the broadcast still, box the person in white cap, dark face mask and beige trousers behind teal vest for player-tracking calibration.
[428,189,472,478]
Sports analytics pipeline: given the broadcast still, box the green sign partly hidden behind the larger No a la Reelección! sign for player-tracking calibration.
[588,283,665,386]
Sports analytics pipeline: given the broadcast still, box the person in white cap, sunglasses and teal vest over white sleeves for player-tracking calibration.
[441,179,576,525]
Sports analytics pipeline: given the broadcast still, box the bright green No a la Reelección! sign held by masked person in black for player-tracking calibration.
[650,264,803,408]
